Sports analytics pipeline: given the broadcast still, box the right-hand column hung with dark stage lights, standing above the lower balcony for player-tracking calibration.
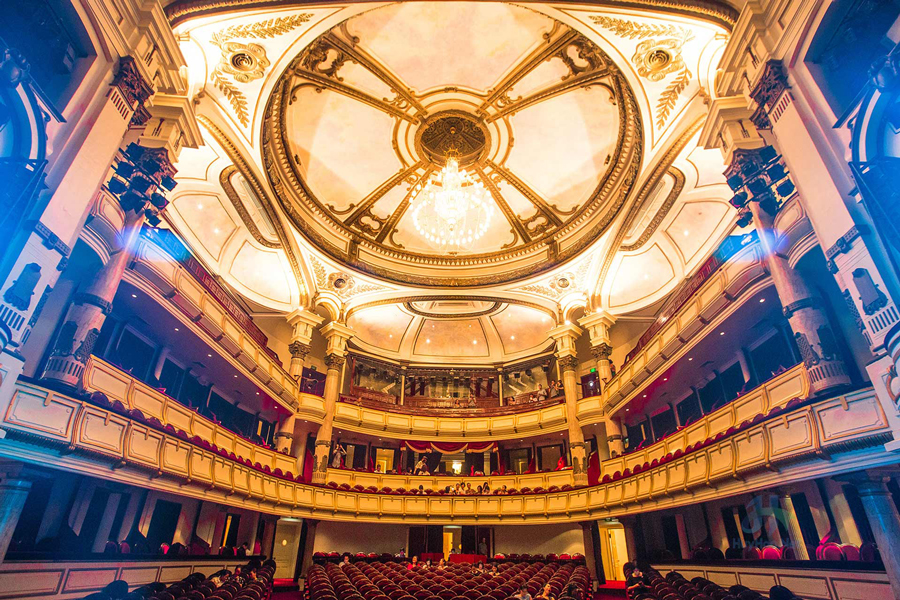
[725,146,850,394]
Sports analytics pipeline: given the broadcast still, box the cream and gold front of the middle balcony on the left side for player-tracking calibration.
[83,356,325,474]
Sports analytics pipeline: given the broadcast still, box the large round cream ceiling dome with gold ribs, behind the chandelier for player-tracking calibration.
[263,2,641,286]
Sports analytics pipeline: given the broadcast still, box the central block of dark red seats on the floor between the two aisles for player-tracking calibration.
[306,561,591,600]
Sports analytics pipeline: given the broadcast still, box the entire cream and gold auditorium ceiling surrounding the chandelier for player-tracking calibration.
[166,1,735,356]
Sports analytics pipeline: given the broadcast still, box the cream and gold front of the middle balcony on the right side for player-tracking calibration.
[592,363,809,477]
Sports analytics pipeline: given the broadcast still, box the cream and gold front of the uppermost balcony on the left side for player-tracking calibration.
[125,235,300,409]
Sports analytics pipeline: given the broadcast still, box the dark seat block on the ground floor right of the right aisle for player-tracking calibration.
[623,563,799,600]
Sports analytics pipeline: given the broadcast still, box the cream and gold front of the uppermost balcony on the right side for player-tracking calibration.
[601,240,770,414]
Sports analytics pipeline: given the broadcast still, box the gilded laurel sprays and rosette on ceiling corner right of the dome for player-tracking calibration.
[591,16,694,129]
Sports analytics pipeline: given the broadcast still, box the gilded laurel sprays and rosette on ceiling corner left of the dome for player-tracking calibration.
[210,13,312,127]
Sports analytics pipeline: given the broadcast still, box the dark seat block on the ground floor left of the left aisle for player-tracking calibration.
[83,560,275,600]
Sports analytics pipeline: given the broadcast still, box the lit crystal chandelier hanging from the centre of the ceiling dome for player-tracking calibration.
[410,156,494,252]
